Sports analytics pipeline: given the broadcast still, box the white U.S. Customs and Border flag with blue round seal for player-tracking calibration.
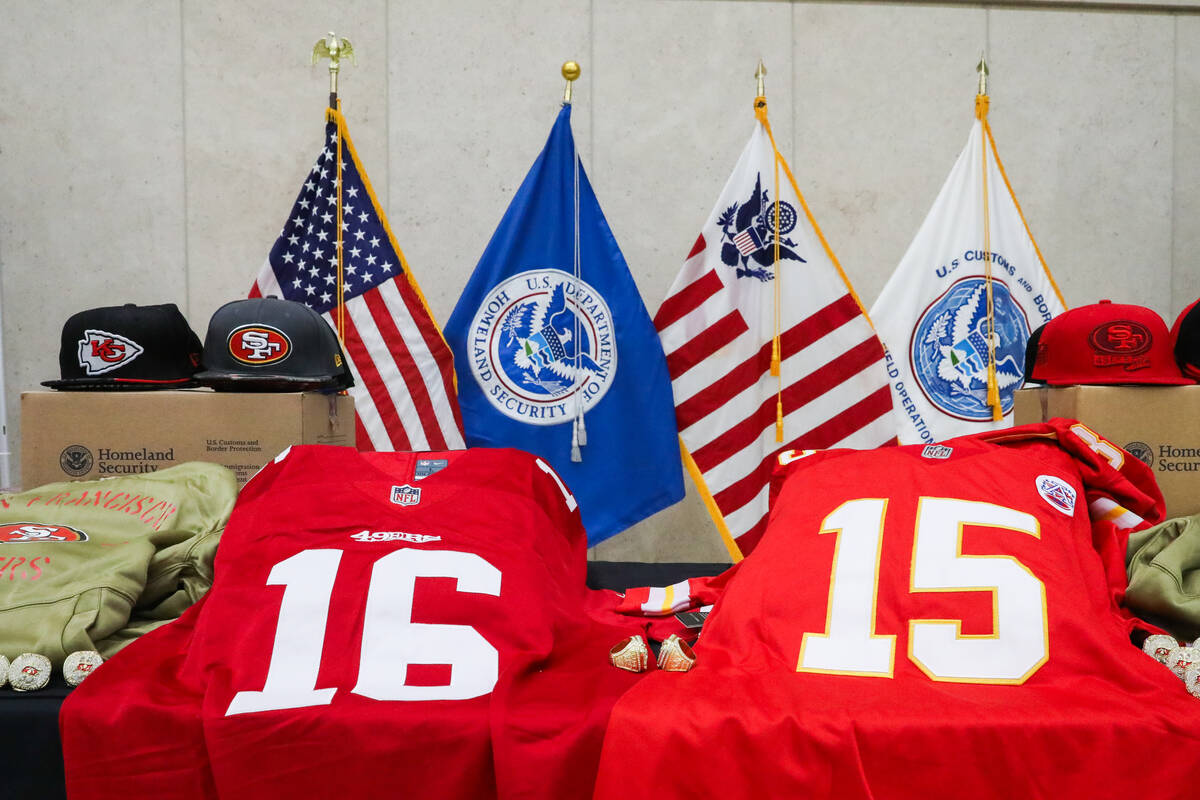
[871,81,1066,444]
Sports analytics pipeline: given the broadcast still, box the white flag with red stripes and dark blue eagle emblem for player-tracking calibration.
[654,96,895,560]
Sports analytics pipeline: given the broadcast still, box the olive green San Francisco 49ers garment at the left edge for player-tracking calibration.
[0,462,238,667]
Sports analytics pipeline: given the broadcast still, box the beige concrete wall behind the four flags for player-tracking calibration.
[0,0,1200,560]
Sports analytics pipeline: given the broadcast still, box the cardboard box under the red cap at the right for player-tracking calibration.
[1013,385,1200,517]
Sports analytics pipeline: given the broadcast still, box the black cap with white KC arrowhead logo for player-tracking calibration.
[42,303,200,391]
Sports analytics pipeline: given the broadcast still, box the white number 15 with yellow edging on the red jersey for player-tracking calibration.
[797,497,1050,684]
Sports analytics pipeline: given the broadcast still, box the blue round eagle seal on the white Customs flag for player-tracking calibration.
[910,277,1030,421]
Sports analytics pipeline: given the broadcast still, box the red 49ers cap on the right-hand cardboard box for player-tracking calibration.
[1025,300,1194,386]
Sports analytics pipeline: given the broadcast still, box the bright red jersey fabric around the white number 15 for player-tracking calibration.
[595,420,1200,800]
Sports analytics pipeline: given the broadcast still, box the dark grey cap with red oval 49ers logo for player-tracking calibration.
[196,297,354,392]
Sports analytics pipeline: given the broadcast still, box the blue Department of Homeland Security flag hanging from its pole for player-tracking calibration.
[444,104,683,545]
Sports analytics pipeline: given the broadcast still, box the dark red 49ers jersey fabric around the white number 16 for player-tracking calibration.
[60,446,643,800]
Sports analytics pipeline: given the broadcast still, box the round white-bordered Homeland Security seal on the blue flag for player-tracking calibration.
[468,269,617,425]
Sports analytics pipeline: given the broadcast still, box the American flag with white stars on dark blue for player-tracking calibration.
[250,110,466,450]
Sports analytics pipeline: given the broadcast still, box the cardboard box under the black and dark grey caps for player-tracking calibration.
[20,390,354,488]
